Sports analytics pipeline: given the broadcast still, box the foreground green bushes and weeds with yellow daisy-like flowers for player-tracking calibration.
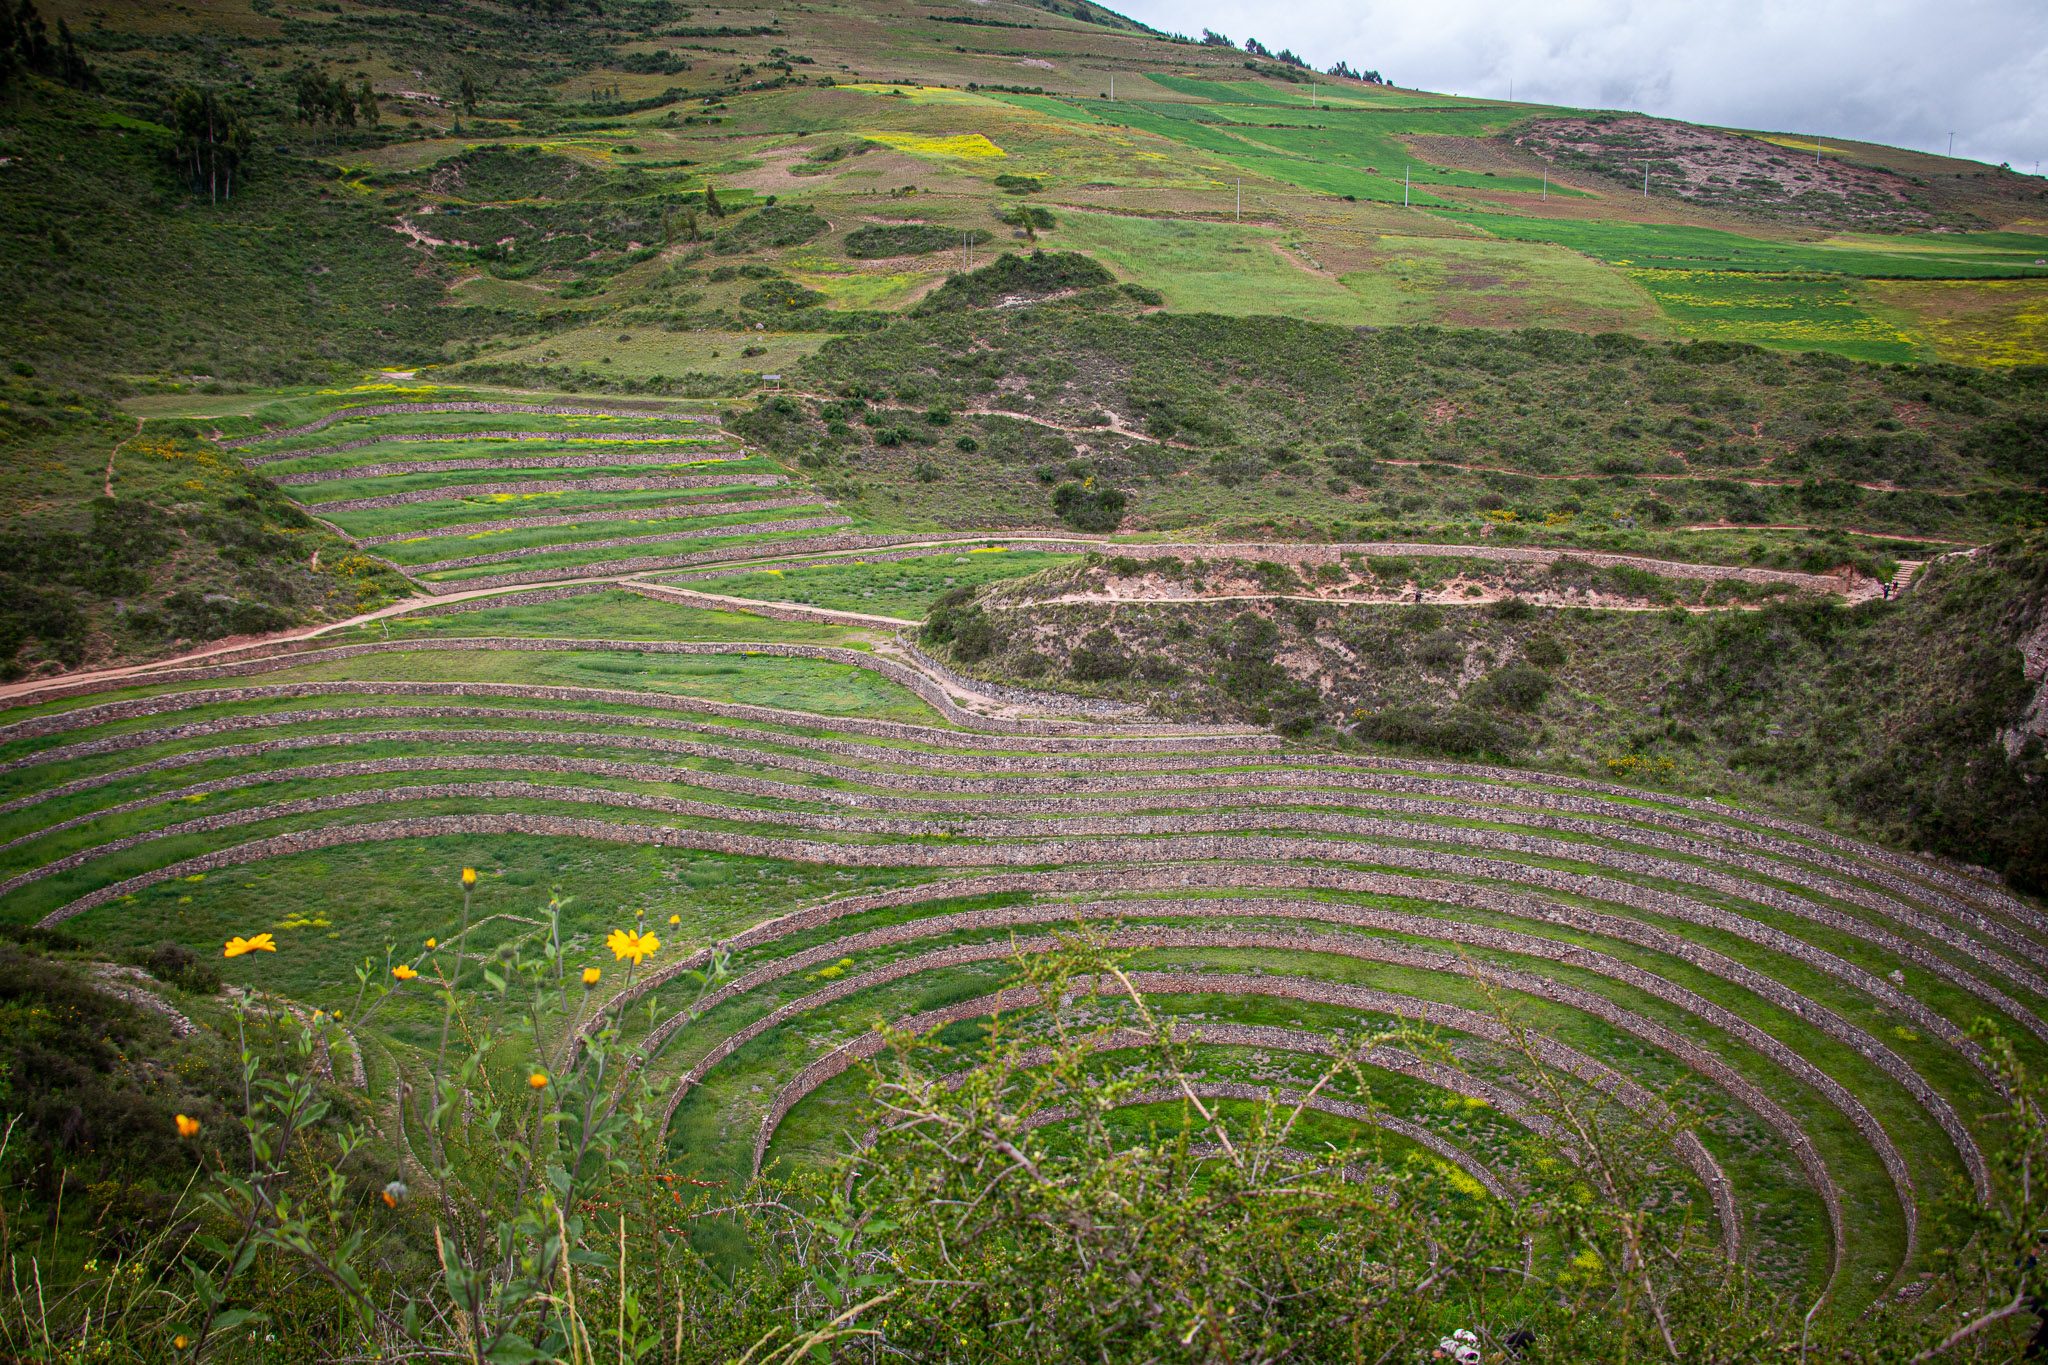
[0,907,2048,1365]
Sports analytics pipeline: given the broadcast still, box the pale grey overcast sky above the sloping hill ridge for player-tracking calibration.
[1116,0,2048,172]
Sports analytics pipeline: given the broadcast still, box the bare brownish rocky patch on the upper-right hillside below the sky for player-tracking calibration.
[1503,115,1941,227]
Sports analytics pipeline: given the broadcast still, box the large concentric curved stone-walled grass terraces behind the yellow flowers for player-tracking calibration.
[0,548,2048,1306]
